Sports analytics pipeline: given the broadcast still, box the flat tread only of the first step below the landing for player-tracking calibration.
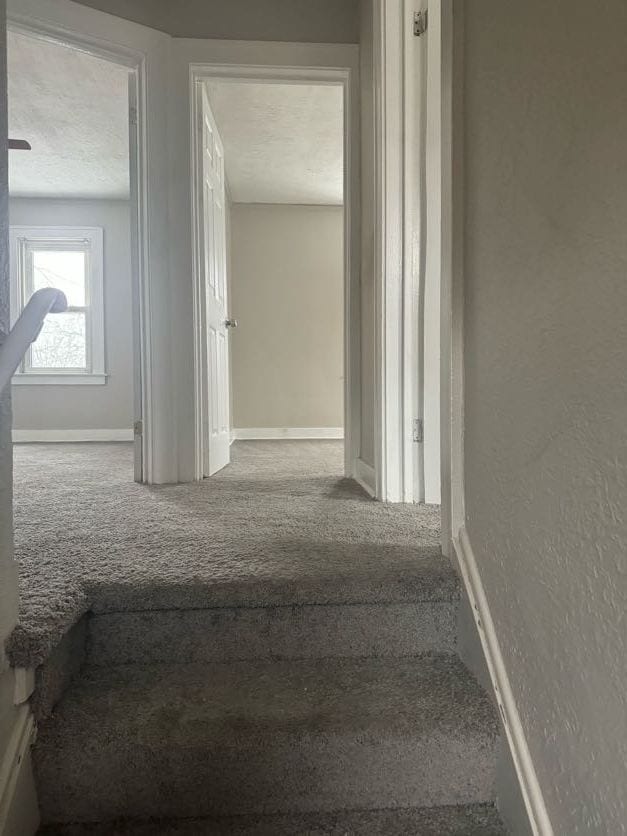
[40,655,498,745]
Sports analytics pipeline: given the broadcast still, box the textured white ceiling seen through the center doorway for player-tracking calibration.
[207,82,344,205]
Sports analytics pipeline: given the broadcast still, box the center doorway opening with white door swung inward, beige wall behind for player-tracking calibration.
[192,68,352,478]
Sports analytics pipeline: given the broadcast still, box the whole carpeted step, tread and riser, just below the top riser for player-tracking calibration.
[34,655,499,832]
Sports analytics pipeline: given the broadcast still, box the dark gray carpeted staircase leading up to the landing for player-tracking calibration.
[9,440,505,836]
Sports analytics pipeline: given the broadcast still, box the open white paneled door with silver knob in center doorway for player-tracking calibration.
[200,85,230,476]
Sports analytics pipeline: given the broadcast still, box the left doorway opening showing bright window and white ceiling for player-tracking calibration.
[7,24,145,481]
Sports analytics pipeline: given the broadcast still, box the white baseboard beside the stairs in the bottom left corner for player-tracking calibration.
[0,705,39,836]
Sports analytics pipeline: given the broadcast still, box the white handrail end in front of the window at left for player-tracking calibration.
[0,287,67,393]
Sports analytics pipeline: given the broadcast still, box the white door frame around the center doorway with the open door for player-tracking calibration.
[180,41,361,479]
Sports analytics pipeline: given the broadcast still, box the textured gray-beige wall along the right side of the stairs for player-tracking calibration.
[465,0,627,836]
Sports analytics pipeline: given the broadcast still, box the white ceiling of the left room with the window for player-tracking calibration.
[8,32,129,198]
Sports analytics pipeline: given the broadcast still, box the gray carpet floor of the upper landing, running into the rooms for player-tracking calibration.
[8,442,448,666]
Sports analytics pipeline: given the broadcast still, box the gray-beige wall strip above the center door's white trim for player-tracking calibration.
[72,0,359,43]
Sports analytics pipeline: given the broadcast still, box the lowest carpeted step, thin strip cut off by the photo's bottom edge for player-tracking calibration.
[39,804,507,836]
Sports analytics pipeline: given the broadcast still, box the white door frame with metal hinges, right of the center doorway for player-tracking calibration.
[373,0,452,506]
